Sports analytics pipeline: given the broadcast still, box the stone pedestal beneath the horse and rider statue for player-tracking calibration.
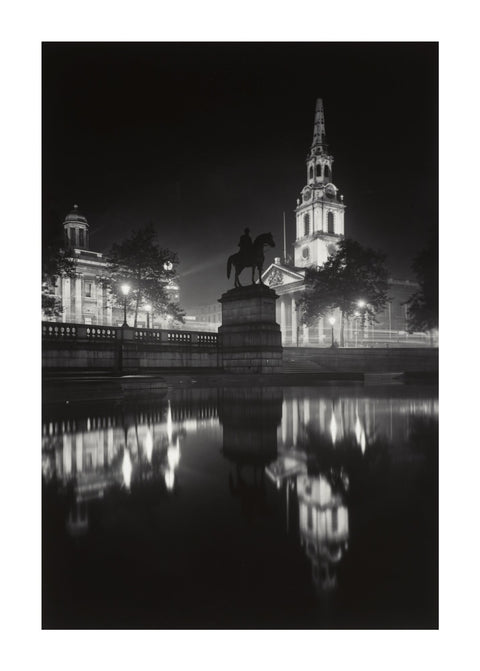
[218,284,282,373]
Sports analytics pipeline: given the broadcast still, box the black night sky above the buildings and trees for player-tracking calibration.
[43,42,438,308]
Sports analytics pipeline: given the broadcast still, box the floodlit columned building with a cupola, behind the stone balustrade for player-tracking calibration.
[47,205,179,328]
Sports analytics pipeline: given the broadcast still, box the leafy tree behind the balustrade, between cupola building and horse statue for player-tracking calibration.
[107,224,184,326]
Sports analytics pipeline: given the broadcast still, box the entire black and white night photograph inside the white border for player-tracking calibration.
[41,41,439,630]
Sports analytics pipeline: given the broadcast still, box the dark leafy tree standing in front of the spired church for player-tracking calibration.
[298,238,388,347]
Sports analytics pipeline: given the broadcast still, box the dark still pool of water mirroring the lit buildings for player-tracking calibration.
[42,385,438,629]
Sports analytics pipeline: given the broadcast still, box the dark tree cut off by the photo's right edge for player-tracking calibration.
[407,229,438,333]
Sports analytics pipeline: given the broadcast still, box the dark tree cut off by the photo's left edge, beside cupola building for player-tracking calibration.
[42,210,76,317]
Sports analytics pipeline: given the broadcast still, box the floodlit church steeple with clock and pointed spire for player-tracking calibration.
[294,98,345,268]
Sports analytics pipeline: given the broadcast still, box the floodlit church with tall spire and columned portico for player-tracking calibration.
[262,98,426,347]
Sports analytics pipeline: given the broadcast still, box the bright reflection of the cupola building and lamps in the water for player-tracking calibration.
[42,398,218,535]
